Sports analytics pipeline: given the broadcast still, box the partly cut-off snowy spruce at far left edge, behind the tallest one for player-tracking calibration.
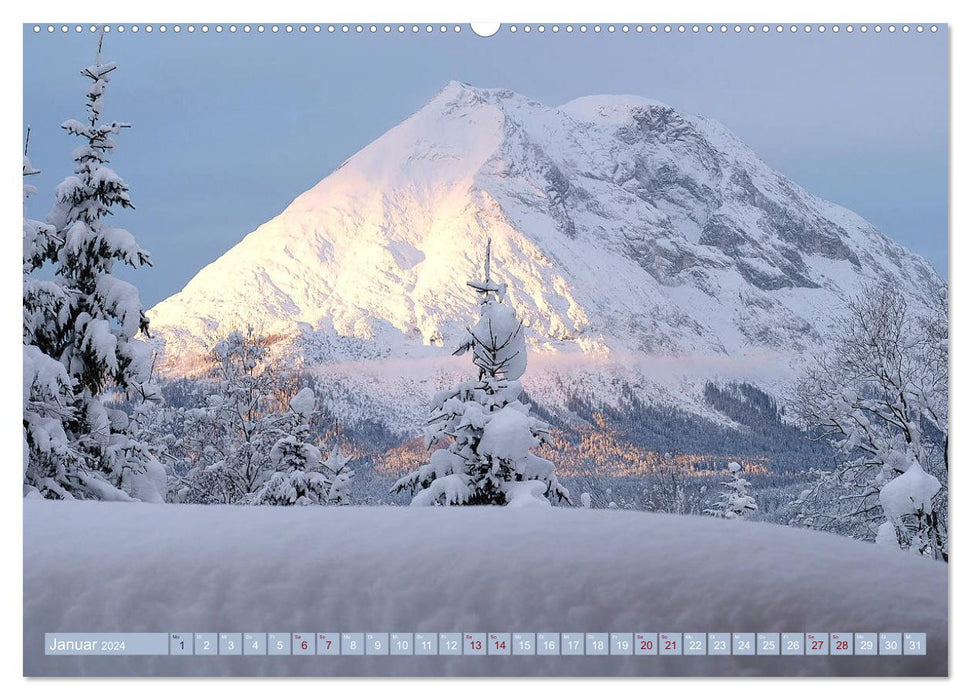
[23,133,78,497]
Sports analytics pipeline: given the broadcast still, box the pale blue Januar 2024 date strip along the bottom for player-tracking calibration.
[44,632,927,657]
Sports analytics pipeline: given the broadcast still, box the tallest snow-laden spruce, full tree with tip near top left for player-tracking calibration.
[25,42,164,501]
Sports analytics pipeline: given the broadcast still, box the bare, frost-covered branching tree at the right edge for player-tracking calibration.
[792,286,948,560]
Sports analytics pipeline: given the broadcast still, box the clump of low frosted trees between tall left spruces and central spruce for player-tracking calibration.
[172,328,354,505]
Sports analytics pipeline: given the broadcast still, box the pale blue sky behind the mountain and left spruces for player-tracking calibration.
[24,27,948,305]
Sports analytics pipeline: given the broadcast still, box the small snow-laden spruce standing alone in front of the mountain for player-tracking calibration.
[392,241,569,506]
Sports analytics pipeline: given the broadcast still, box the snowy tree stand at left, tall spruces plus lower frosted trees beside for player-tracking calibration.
[23,41,354,504]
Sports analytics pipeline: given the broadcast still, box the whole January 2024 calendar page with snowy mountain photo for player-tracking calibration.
[21,17,949,677]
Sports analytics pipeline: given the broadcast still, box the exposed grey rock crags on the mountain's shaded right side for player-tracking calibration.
[517,105,872,290]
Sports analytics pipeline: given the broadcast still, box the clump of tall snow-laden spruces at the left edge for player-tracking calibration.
[23,38,164,501]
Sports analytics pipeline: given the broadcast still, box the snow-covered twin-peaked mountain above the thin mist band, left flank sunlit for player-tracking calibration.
[149,82,942,426]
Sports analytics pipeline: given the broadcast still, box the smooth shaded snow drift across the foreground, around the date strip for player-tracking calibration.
[24,501,948,676]
